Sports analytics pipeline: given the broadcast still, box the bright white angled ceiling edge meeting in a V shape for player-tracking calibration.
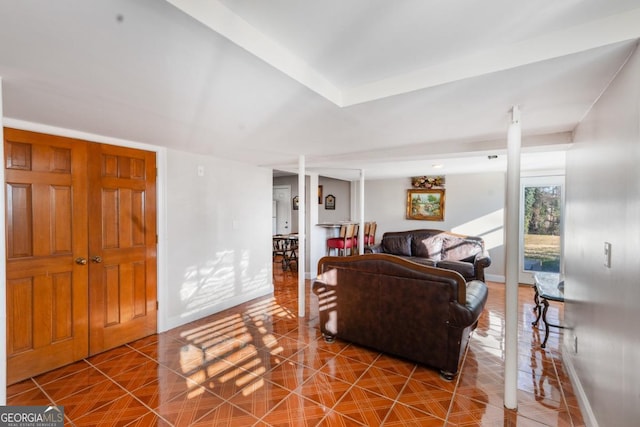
[167,0,640,107]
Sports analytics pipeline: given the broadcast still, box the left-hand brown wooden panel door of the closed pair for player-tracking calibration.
[4,129,89,384]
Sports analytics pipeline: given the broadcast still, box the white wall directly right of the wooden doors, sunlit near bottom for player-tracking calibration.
[161,150,273,330]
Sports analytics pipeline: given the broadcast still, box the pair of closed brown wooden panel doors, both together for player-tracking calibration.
[4,128,157,384]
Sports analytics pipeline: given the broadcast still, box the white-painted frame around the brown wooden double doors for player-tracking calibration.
[0,121,169,405]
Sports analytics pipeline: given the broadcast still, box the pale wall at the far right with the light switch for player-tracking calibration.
[563,42,640,426]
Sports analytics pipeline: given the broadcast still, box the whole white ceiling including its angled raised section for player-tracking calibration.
[0,0,640,179]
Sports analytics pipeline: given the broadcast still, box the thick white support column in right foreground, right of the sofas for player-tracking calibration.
[504,105,522,409]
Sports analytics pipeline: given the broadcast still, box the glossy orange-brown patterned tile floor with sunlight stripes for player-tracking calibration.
[7,263,584,427]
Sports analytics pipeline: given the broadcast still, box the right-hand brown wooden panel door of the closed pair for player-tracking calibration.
[88,144,156,354]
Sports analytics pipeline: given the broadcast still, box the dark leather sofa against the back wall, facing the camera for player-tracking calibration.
[365,229,491,281]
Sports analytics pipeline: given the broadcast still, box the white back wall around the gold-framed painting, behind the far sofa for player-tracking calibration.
[364,172,505,281]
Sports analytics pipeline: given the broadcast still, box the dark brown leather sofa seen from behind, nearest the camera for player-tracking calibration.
[312,254,488,380]
